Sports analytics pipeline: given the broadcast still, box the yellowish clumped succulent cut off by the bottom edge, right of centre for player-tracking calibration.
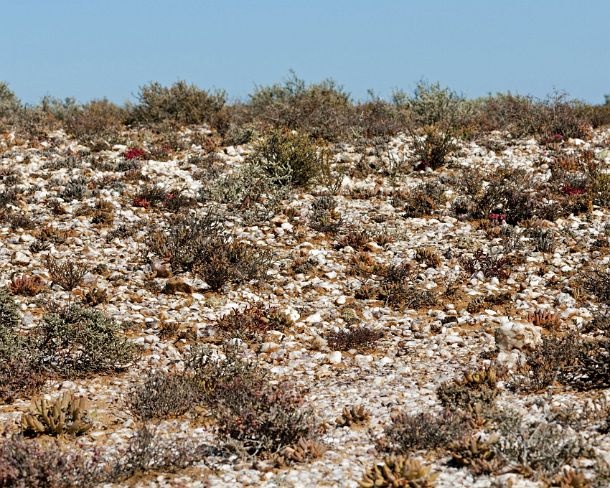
[358,456,438,488]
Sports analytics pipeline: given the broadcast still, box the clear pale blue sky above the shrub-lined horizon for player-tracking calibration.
[0,0,610,103]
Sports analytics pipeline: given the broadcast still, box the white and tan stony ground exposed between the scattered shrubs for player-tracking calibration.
[0,127,610,487]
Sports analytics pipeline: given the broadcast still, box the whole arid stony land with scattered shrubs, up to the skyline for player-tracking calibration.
[0,82,610,488]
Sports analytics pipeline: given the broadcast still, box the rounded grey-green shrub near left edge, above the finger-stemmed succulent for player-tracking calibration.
[33,305,138,377]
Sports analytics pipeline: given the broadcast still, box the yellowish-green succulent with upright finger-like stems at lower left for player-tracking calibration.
[21,392,91,436]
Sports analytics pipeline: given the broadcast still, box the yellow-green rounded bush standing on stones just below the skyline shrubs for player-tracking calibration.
[248,129,329,186]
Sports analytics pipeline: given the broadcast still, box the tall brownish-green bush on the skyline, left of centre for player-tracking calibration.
[131,81,225,124]
